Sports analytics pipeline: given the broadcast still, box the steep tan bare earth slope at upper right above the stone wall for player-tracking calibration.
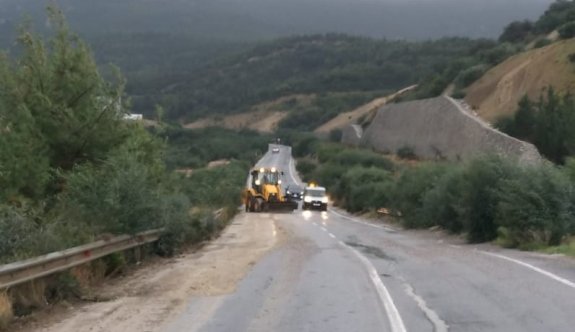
[465,39,575,123]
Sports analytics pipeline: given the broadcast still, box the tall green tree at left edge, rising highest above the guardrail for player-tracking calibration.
[0,7,127,200]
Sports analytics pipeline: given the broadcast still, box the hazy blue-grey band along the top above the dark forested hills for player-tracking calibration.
[0,0,552,39]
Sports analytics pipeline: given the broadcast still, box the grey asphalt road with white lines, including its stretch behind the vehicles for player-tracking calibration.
[167,146,575,332]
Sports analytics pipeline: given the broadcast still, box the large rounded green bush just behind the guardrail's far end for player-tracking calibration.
[64,138,169,234]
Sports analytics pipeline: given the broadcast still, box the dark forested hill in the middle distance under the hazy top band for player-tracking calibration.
[129,34,506,124]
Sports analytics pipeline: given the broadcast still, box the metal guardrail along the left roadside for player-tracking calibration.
[0,229,162,289]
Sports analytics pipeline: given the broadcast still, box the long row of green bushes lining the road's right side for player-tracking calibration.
[296,141,575,252]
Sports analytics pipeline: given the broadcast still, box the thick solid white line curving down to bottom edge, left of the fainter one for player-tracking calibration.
[345,245,407,332]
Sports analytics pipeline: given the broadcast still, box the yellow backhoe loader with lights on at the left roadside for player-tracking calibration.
[244,167,298,212]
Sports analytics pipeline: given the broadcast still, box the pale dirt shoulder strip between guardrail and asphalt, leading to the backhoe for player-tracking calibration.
[22,214,284,332]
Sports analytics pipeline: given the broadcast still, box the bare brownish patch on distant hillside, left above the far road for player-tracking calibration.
[184,95,313,133]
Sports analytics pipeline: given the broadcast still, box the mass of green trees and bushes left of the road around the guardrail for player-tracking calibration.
[0,8,268,328]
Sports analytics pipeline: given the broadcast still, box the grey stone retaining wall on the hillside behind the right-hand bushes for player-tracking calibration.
[342,96,541,163]
